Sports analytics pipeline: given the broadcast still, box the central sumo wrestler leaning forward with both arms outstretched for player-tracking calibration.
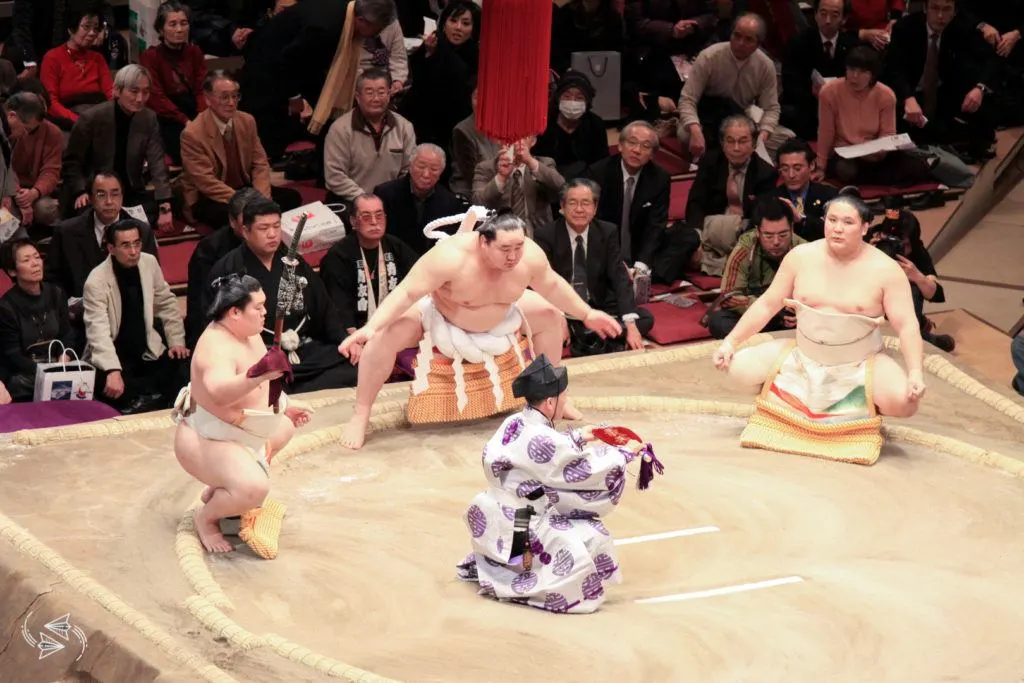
[339,213,623,449]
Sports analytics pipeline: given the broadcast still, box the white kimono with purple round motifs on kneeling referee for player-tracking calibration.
[459,408,636,613]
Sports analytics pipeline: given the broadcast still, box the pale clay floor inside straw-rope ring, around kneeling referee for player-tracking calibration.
[203,413,1024,683]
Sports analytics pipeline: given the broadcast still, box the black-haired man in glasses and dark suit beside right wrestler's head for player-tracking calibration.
[762,138,839,242]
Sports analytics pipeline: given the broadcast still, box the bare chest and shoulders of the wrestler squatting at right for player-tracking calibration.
[791,240,902,317]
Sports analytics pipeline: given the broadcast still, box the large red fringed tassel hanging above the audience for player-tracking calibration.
[476,0,553,144]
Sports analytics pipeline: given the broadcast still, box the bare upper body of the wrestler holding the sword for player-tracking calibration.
[191,324,270,424]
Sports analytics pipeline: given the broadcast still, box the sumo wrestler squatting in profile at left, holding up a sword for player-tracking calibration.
[174,274,309,553]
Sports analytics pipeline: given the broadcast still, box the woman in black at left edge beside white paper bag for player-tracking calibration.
[0,239,77,401]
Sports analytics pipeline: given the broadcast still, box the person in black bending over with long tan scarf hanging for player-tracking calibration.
[240,0,397,161]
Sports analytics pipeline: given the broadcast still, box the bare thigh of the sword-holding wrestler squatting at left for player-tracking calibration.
[174,424,267,495]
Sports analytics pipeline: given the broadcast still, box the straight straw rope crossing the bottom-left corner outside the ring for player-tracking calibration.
[0,514,238,683]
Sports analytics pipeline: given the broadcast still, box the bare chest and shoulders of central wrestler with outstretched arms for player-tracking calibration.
[423,232,547,332]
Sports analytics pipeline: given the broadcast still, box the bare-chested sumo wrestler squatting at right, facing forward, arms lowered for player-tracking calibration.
[714,196,925,418]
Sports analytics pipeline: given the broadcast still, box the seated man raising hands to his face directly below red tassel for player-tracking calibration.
[473,135,565,238]
